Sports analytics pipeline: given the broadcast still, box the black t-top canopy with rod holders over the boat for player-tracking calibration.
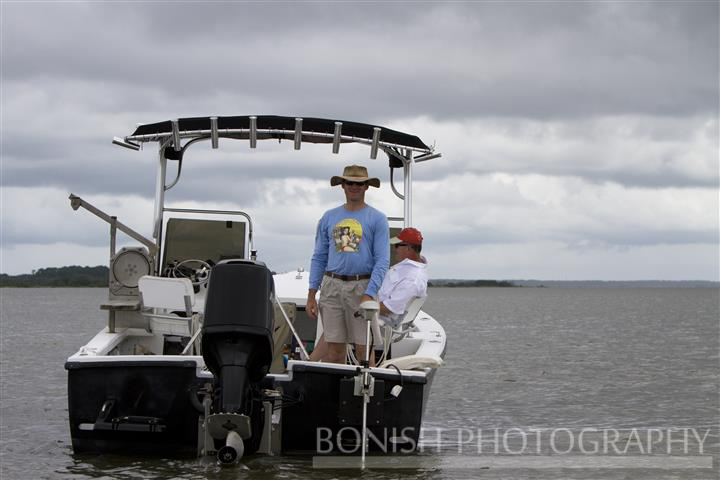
[125,115,433,153]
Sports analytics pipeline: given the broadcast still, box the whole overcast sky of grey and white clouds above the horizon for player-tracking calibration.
[0,1,720,280]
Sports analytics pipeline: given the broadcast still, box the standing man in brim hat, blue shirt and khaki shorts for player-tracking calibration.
[305,165,390,363]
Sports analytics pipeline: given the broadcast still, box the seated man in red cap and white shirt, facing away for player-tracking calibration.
[310,227,428,361]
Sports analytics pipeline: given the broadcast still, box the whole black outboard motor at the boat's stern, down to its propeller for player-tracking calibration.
[202,260,275,463]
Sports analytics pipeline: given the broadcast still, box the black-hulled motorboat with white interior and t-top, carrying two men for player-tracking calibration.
[65,116,446,464]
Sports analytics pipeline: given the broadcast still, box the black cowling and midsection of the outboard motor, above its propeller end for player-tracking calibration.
[202,260,275,413]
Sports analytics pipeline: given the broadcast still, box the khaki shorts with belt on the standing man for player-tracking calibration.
[318,276,381,345]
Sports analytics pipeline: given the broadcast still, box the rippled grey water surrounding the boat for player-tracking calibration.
[0,288,720,480]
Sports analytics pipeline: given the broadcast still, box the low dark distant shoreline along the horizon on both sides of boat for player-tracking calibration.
[0,265,720,288]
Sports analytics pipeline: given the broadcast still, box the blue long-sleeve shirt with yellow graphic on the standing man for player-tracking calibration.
[310,205,390,297]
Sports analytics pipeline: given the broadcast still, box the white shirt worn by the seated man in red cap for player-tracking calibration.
[378,258,428,324]
